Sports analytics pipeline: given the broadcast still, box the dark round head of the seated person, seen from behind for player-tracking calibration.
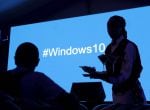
[15,42,39,69]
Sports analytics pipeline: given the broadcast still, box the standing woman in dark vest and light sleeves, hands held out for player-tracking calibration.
[82,15,146,110]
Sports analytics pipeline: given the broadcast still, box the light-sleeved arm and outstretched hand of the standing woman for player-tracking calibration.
[82,43,136,84]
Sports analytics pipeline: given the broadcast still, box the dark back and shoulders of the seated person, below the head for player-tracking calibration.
[8,68,71,110]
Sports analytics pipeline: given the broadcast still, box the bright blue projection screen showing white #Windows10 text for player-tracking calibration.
[8,7,150,101]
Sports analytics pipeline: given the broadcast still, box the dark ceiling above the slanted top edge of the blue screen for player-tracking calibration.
[0,0,150,25]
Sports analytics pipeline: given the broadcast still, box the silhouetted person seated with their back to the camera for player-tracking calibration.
[0,42,78,110]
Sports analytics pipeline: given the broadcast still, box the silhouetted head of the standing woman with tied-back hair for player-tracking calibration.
[107,15,127,40]
